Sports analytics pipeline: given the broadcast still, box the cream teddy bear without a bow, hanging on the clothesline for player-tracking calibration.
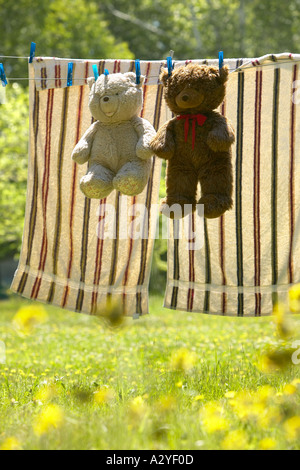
[72,72,156,199]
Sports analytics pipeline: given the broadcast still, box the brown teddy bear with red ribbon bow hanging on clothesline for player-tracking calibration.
[150,63,235,218]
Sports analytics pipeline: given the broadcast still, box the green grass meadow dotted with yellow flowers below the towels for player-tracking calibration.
[0,296,300,450]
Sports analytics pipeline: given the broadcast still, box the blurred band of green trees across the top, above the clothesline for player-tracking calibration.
[0,0,300,76]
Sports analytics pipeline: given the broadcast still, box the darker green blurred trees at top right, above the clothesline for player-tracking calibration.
[99,0,300,60]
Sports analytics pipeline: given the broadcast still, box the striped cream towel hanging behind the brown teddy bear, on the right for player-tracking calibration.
[165,53,300,316]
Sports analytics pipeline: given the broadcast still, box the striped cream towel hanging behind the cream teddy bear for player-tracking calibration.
[12,58,164,315]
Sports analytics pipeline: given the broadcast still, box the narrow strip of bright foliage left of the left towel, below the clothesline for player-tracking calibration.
[0,84,29,259]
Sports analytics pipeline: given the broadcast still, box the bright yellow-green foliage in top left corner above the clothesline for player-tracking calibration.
[0,0,133,77]
